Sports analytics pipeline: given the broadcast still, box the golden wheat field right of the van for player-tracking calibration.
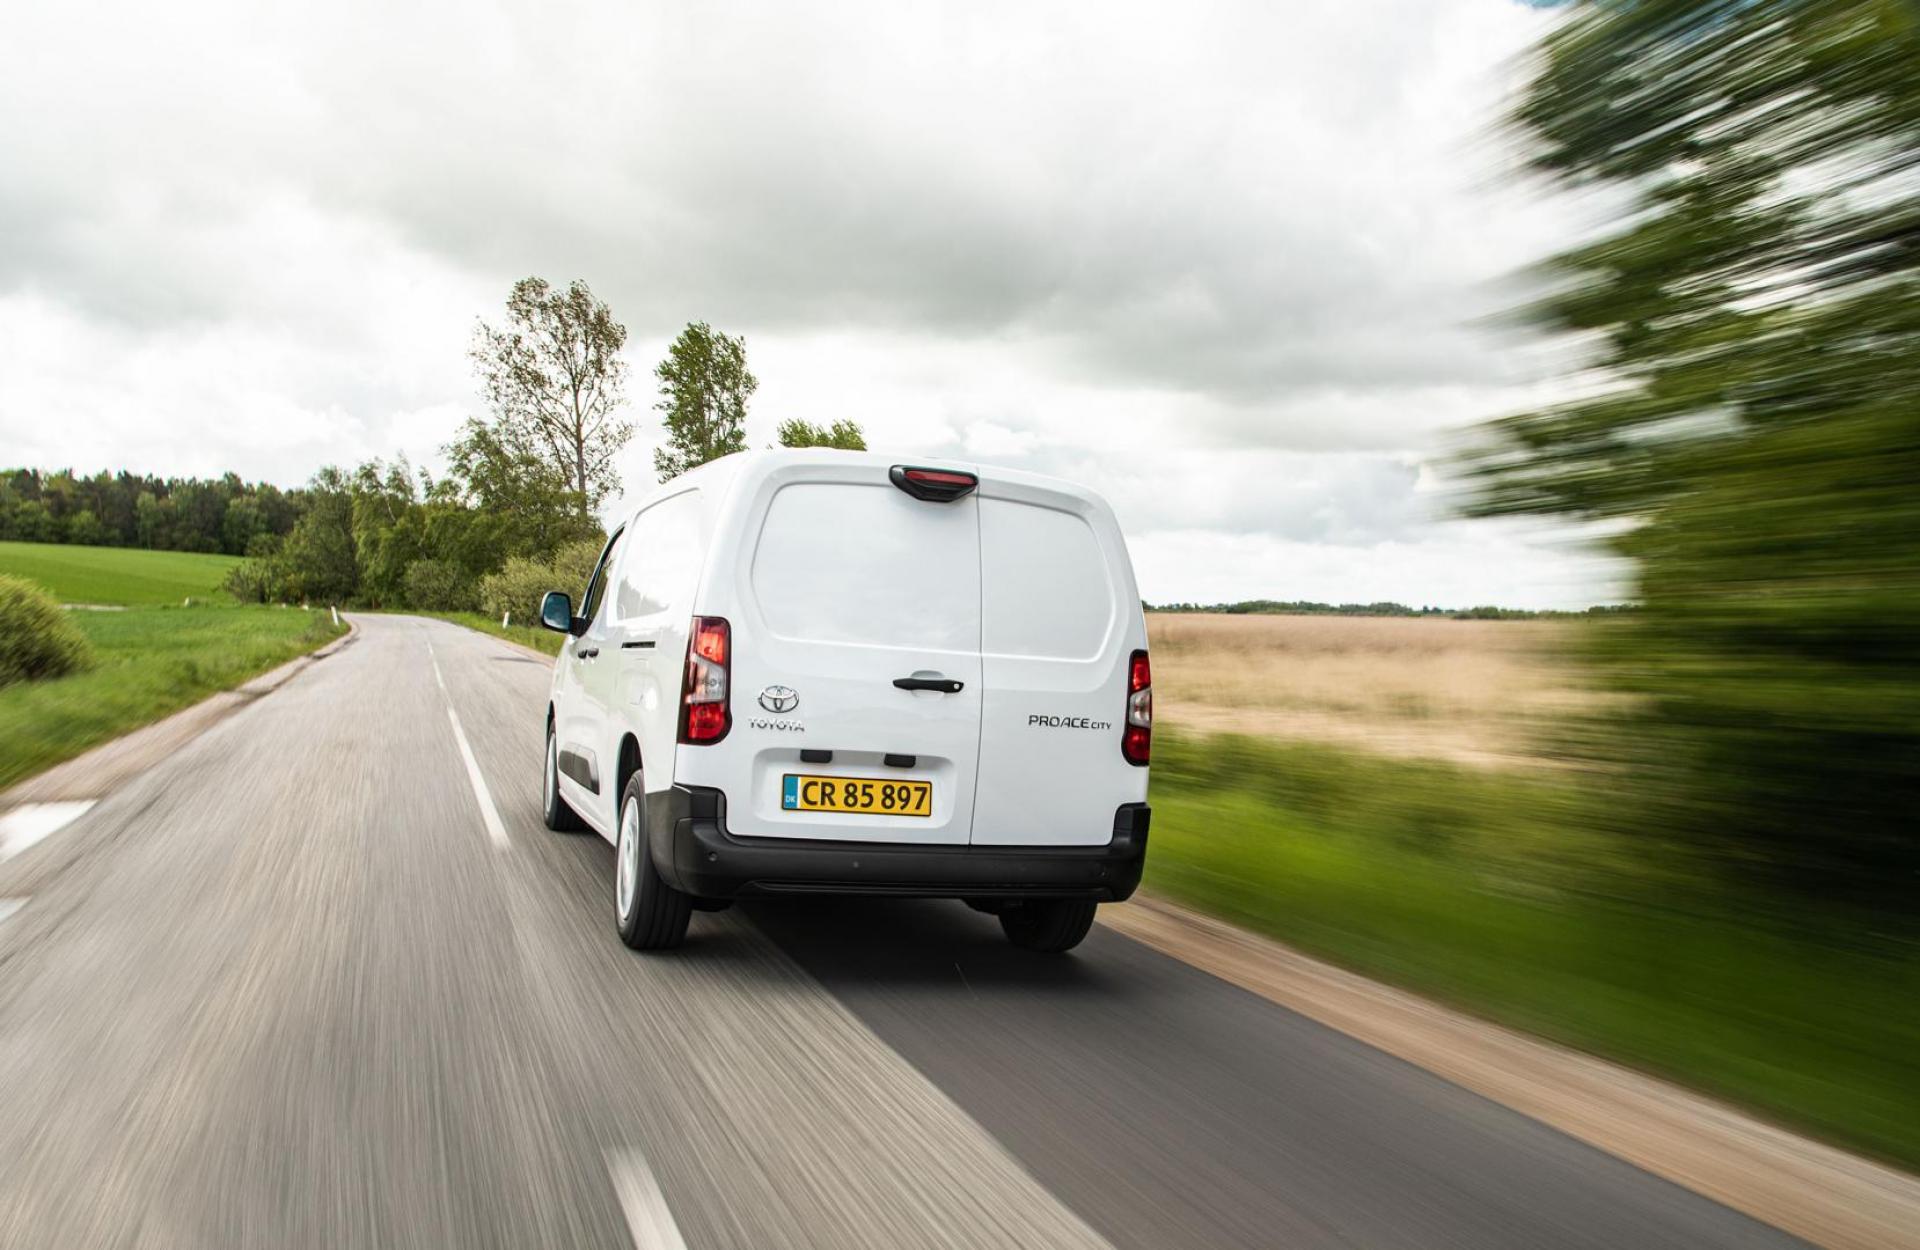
[1146,613,1597,766]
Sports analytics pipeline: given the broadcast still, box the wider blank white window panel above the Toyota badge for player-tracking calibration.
[753,482,979,651]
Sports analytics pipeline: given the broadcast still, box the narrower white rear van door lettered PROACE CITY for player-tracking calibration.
[972,472,1146,847]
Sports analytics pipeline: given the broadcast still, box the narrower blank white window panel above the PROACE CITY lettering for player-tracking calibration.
[979,499,1114,661]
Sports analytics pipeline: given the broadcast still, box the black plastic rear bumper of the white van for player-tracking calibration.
[647,785,1150,902]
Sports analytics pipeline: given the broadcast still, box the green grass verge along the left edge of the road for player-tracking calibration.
[0,607,346,787]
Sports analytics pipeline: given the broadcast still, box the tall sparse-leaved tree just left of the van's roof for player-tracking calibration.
[472,278,634,511]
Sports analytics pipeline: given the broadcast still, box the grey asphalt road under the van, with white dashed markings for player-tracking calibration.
[0,616,1799,1250]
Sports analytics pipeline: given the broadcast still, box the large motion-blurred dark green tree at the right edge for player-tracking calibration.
[1467,0,1920,902]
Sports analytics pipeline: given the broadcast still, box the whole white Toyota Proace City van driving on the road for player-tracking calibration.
[541,449,1152,950]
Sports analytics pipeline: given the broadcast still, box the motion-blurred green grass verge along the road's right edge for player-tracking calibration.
[1146,735,1920,1169]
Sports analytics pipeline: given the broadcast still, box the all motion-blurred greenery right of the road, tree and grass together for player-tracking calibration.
[1148,0,1920,1167]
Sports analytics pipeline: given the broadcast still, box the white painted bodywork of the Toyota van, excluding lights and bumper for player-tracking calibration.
[553,449,1146,849]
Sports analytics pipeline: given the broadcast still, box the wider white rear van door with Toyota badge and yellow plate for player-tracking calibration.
[721,461,981,845]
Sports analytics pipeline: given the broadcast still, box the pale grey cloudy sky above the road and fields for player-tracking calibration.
[0,0,1619,607]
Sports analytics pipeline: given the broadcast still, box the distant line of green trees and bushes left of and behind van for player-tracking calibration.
[0,278,866,613]
